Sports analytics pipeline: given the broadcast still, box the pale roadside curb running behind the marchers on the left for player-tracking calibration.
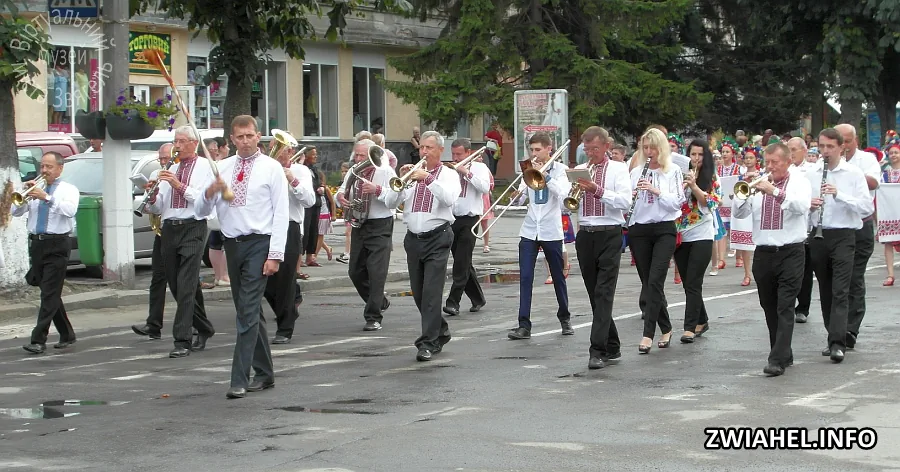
[0,257,518,323]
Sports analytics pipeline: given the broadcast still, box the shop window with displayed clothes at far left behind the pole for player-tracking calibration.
[47,46,101,133]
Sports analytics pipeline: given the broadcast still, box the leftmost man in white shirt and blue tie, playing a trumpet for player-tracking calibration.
[12,152,80,354]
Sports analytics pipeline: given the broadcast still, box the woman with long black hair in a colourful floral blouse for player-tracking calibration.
[675,139,721,343]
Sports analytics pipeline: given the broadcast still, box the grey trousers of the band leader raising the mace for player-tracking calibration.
[225,235,275,388]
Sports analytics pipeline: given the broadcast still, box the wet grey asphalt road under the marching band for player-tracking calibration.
[0,236,900,472]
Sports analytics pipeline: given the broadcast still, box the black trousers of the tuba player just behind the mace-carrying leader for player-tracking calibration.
[263,221,303,338]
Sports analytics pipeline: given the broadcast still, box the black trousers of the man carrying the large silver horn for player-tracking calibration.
[347,217,394,323]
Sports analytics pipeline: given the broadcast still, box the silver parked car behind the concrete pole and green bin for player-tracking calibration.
[62,151,159,276]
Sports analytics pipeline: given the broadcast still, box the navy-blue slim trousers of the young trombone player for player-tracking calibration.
[519,238,572,330]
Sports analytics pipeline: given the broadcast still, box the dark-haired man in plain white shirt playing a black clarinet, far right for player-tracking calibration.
[807,128,874,362]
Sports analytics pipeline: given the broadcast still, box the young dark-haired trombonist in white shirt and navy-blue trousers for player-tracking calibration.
[507,131,572,339]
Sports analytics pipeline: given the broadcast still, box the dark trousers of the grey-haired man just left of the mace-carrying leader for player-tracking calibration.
[160,220,216,349]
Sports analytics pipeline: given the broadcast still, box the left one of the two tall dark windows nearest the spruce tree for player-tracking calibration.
[303,64,339,138]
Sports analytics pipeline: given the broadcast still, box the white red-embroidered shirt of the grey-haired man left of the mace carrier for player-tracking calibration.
[147,157,215,221]
